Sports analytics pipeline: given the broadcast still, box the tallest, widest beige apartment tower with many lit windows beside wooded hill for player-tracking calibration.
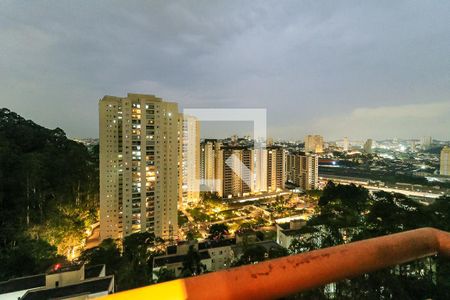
[99,94,179,239]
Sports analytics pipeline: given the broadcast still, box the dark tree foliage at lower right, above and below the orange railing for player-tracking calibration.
[290,182,450,299]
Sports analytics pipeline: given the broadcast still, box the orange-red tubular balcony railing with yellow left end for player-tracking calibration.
[104,228,450,300]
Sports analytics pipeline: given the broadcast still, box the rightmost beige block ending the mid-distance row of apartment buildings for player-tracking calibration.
[286,153,319,190]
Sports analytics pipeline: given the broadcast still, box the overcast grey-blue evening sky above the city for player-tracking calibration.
[0,0,450,140]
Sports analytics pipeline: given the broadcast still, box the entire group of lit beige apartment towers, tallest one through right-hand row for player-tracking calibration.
[99,94,324,240]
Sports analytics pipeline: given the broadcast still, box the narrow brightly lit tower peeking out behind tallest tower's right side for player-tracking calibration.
[178,114,200,207]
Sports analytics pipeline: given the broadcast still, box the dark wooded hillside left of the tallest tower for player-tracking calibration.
[0,109,99,276]
